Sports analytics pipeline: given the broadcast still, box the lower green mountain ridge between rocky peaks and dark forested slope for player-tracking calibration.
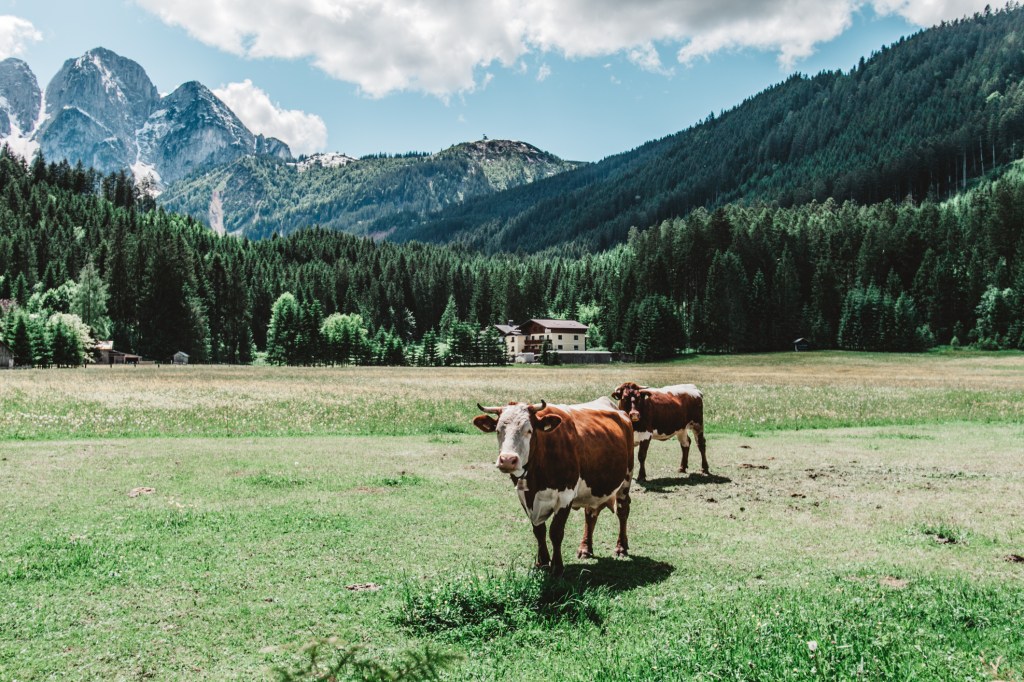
[160,139,582,239]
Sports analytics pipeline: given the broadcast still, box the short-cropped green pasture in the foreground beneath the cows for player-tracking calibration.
[0,423,1024,681]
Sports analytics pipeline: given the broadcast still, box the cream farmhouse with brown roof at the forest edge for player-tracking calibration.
[495,318,611,364]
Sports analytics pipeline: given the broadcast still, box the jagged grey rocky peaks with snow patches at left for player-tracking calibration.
[0,48,291,184]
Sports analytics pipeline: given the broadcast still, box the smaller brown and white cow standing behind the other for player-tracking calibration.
[611,381,710,480]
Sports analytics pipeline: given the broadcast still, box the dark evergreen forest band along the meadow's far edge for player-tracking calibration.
[0,148,1024,365]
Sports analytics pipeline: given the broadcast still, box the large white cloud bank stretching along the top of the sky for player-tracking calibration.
[134,0,990,99]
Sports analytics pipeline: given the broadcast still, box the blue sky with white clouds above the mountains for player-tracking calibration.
[0,0,999,161]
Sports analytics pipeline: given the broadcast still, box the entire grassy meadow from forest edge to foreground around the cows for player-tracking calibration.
[0,353,1024,680]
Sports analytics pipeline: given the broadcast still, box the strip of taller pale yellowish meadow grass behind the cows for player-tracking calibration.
[0,352,1024,439]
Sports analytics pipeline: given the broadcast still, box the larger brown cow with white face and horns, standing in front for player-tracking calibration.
[473,400,633,576]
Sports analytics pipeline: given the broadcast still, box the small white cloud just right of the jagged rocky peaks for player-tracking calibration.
[213,79,327,155]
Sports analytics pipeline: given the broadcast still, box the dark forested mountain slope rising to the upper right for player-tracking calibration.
[382,5,1024,252]
